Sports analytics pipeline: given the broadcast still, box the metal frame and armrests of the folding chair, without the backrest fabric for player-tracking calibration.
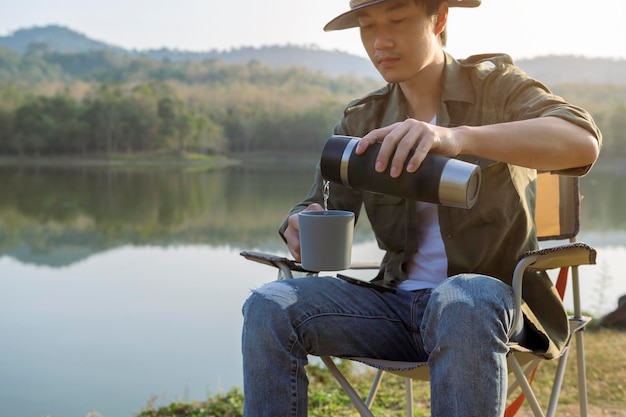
[241,173,596,417]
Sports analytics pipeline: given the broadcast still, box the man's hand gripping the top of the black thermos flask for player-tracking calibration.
[356,119,460,178]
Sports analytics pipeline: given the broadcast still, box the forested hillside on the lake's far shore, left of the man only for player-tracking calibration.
[0,54,379,155]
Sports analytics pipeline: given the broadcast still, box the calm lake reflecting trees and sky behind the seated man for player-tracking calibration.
[0,163,626,417]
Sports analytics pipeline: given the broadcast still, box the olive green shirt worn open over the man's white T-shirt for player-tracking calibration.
[280,54,601,358]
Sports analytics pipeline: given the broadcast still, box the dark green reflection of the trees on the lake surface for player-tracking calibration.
[0,162,626,266]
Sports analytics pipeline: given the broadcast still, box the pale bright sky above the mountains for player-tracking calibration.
[0,0,626,59]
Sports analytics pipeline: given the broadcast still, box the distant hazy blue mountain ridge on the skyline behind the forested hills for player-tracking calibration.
[0,25,626,85]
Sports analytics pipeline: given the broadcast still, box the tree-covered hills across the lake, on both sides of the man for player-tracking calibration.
[0,25,626,156]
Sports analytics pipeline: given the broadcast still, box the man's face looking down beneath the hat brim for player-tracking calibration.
[358,0,441,82]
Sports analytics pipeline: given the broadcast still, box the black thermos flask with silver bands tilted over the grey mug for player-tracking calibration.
[320,135,480,208]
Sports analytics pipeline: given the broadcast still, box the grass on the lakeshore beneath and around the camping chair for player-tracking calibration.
[138,328,626,417]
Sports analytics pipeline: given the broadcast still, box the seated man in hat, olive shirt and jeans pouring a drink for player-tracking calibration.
[242,0,601,417]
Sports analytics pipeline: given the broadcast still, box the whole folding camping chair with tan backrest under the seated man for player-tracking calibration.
[241,173,596,417]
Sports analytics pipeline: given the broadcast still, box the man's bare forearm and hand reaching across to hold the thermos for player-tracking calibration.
[356,117,599,177]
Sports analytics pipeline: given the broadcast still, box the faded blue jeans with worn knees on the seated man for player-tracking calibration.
[242,274,513,417]
